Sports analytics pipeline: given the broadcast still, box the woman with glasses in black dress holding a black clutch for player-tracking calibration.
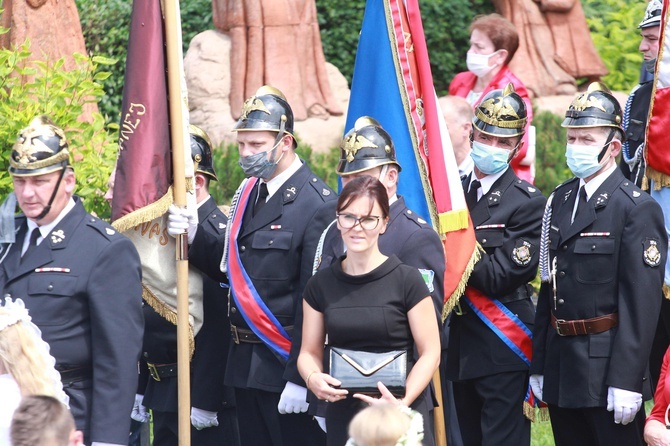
[298,176,440,446]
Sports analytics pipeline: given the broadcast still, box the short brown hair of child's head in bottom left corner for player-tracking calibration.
[10,395,74,446]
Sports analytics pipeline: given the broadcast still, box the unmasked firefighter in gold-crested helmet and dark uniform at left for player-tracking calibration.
[0,116,144,446]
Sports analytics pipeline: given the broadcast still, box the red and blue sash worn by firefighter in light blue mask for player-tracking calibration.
[465,287,546,420]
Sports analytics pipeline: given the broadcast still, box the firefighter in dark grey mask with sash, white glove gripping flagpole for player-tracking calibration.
[169,86,336,446]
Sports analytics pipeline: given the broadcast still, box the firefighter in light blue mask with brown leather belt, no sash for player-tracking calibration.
[531,83,668,446]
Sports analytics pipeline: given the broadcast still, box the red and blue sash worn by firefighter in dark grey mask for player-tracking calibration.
[228,178,291,359]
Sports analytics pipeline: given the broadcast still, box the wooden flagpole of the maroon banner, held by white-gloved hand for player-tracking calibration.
[164,0,191,446]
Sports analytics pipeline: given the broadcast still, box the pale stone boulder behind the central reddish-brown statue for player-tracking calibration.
[184,30,349,152]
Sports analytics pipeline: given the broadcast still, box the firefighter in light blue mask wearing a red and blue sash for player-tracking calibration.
[446,84,546,446]
